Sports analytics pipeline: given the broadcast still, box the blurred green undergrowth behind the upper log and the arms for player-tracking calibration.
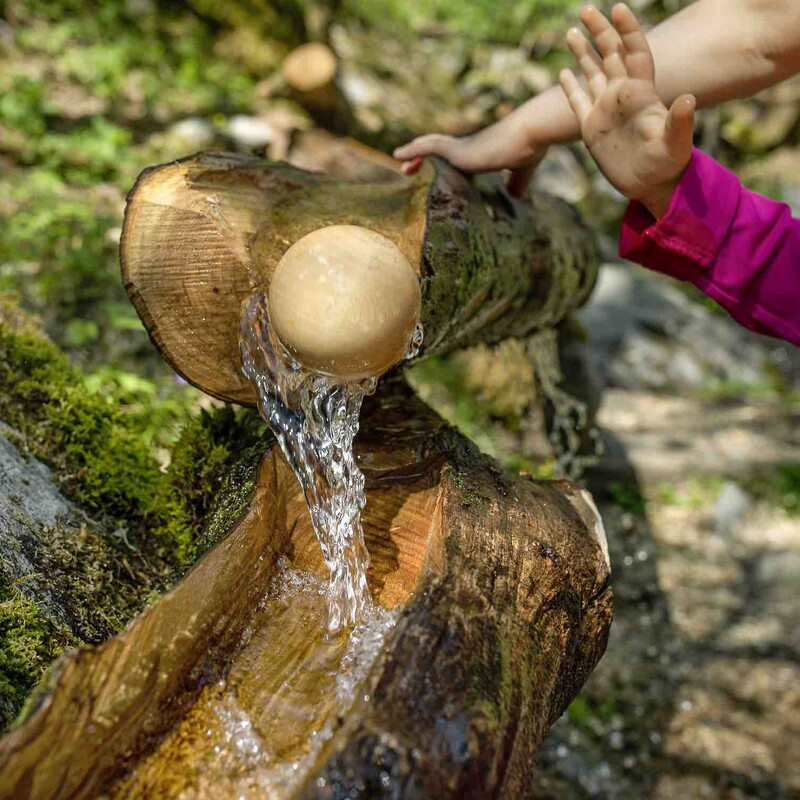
[0,0,798,468]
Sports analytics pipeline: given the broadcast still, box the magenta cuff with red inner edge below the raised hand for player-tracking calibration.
[619,149,739,280]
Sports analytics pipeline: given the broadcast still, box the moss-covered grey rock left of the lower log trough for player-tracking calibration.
[0,298,268,729]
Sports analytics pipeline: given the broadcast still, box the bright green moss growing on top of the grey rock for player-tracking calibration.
[0,302,264,566]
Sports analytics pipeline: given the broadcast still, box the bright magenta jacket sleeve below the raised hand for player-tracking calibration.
[619,150,800,345]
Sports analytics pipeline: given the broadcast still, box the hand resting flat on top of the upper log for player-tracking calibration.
[394,131,547,197]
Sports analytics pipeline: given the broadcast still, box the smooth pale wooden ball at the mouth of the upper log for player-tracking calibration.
[268,225,420,381]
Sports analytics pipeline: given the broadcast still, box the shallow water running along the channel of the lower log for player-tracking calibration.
[113,557,398,800]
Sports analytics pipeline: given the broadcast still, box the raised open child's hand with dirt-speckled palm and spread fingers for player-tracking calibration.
[560,3,695,217]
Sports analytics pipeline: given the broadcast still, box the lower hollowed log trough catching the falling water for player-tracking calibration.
[0,380,611,800]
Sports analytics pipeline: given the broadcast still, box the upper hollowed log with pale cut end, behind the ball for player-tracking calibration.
[120,144,596,405]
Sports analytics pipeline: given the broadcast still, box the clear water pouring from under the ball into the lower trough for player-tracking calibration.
[239,290,422,631]
